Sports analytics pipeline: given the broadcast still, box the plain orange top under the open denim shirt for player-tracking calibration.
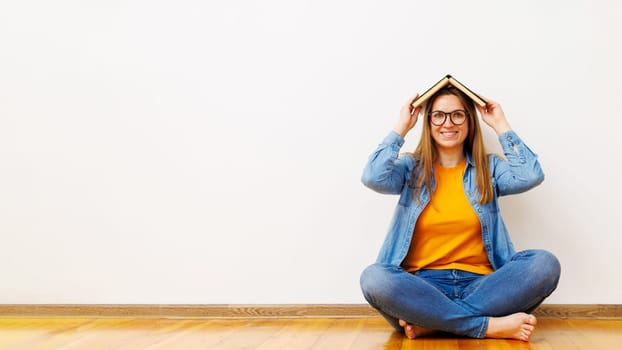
[402,161,493,274]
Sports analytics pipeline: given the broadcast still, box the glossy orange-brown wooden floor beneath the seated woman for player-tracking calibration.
[0,317,622,350]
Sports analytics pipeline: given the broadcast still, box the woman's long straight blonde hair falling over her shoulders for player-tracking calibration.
[410,86,493,204]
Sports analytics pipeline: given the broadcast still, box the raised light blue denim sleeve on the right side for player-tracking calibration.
[491,130,544,196]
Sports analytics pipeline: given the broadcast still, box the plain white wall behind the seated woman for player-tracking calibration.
[0,0,622,303]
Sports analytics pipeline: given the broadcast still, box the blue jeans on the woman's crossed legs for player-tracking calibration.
[361,250,560,338]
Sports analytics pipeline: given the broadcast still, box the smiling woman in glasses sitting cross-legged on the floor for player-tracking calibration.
[361,87,560,341]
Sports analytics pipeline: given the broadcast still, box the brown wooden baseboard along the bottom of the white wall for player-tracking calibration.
[0,304,622,319]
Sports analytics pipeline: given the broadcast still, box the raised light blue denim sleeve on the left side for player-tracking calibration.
[361,131,414,194]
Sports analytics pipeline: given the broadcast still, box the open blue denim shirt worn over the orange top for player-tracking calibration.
[362,130,544,270]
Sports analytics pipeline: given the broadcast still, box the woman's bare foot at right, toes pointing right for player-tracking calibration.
[486,312,538,341]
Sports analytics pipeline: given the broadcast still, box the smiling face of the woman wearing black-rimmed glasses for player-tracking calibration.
[430,95,469,151]
